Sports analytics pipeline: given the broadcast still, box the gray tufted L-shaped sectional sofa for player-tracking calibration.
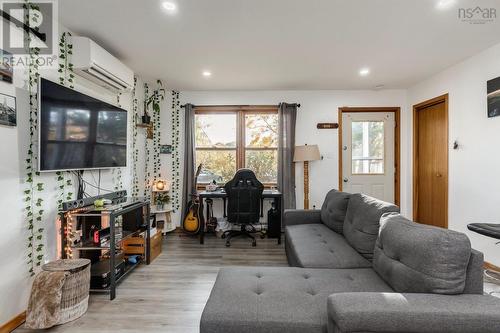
[200,190,500,333]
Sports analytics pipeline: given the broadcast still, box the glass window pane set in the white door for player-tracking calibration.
[351,121,384,175]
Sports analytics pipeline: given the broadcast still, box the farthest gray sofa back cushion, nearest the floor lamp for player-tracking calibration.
[321,190,351,234]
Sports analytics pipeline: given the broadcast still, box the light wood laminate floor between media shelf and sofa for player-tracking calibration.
[14,234,287,333]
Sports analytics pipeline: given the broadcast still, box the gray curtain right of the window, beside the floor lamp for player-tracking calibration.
[278,103,297,209]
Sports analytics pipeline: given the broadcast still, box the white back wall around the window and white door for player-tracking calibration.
[180,90,410,220]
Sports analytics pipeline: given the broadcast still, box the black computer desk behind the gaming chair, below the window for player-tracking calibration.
[198,190,283,244]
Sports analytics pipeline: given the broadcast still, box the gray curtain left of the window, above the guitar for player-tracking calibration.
[181,104,196,221]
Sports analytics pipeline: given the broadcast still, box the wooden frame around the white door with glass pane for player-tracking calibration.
[338,106,401,206]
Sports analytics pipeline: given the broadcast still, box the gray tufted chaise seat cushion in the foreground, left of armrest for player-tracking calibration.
[200,267,392,333]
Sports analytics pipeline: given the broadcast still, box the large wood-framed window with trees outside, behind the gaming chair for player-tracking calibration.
[195,106,278,186]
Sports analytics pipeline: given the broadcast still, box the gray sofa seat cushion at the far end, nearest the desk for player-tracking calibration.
[285,224,371,268]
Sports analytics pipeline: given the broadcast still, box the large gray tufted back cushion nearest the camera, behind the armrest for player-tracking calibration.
[373,214,471,294]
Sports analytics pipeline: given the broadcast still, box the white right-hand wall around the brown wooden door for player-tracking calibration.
[408,40,500,265]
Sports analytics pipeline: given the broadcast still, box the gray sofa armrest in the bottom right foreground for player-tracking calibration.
[328,293,500,333]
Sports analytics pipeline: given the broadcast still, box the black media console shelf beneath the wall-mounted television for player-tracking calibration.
[59,191,151,300]
